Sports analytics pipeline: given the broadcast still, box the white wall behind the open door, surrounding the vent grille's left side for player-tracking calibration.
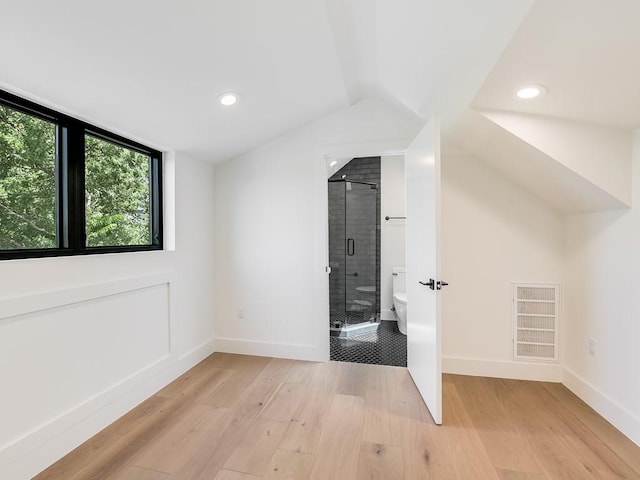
[441,154,564,381]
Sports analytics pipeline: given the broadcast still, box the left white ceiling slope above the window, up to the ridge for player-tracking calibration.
[0,0,349,161]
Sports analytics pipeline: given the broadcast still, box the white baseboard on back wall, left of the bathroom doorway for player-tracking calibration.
[215,336,329,362]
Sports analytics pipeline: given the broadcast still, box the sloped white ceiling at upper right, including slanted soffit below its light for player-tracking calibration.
[448,0,640,213]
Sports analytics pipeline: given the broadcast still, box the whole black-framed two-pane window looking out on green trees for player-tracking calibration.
[0,91,162,259]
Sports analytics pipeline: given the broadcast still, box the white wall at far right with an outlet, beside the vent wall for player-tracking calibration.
[564,131,640,445]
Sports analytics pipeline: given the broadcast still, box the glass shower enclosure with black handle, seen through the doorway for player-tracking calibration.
[329,179,380,336]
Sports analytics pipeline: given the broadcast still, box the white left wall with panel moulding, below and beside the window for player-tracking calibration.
[0,154,218,480]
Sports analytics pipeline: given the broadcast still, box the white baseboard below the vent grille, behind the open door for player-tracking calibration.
[442,357,562,383]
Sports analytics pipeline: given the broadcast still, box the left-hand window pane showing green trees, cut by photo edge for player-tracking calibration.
[0,105,57,250]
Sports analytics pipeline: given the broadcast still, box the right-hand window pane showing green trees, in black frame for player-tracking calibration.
[85,135,151,247]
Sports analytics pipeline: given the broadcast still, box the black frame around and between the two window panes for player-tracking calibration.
[0,89,164,260]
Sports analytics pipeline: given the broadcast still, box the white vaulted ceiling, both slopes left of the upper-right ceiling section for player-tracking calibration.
[0,0,532,162]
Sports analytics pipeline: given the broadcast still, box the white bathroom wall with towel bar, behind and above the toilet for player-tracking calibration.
[380,155,406,320]
